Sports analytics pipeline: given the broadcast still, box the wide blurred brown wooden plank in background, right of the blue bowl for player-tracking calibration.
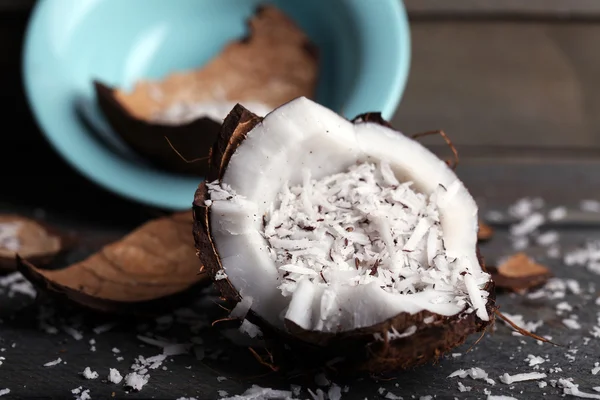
[393,21,600,156]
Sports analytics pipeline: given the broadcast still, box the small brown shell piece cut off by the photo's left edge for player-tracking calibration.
[0,214,70,271]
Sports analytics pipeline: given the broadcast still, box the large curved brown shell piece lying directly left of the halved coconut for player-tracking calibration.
[19,212,205,313]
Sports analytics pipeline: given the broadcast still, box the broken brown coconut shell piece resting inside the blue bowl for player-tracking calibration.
[95,6,318,175]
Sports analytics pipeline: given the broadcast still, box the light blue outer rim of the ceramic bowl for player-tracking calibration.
[21,0,411,210]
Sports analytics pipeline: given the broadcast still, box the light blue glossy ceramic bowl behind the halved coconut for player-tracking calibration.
[23,0,410,209]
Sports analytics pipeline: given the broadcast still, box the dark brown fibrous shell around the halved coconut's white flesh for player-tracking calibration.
[193,105,497,373]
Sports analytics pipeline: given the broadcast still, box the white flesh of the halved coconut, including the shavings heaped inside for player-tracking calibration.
[207,98,490,332]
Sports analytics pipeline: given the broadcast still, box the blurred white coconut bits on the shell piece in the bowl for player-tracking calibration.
[152,101,272,125]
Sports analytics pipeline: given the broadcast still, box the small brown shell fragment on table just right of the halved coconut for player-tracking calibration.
[488,253,552,292]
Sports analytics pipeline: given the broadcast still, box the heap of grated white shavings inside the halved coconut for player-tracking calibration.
[258,162,489,320]
